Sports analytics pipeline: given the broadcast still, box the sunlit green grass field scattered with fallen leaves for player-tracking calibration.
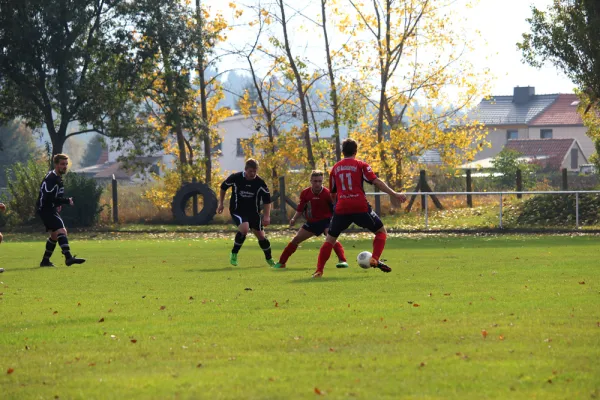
[0,233,600,399]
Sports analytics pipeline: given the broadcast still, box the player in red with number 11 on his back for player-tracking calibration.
[312,139,406,278]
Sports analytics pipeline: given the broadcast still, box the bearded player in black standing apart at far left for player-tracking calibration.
[37,154,85,267]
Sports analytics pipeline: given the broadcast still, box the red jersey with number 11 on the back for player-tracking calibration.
[329,158,377,214]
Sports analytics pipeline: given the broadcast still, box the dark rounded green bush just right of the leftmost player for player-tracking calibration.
[60,172,103,228]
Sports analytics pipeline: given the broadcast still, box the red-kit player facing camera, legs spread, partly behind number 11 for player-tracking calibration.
[273,170,348,269]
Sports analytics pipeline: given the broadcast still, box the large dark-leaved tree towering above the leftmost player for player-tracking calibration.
[0,0,143,154]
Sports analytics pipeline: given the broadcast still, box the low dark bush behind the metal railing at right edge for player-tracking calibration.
[517,194,600,225]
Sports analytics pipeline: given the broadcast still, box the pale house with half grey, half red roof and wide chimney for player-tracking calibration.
[468,87,595,164]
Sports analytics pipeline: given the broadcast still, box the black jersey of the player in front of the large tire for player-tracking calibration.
[221,172,271,214]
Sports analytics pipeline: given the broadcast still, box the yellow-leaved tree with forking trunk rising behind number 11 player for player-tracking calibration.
[340,0,489,187]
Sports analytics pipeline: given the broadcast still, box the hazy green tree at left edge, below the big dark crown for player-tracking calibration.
[0,121,39,187]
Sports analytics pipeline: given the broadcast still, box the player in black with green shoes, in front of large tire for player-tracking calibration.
[217,158,275,266]
